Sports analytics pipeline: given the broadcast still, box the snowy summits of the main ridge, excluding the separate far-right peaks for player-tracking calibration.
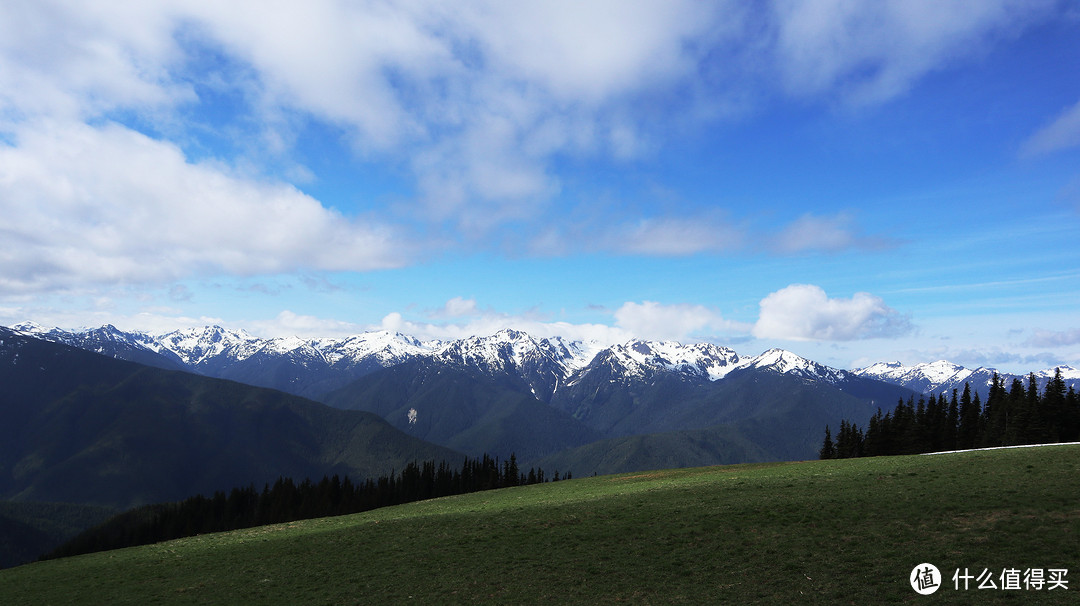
[13,323,859,400]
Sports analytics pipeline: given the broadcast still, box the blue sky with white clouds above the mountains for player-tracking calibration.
[0,0,1080,373]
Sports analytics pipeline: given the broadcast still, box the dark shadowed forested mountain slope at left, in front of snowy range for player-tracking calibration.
[0,329,460,508]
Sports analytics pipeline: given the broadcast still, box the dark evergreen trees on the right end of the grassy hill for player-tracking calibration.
[820,368,1080,459]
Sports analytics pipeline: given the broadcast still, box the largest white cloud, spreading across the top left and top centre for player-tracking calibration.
[0,0,726,238]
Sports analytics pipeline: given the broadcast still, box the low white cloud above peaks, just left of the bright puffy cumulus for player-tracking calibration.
[615,301,747,341]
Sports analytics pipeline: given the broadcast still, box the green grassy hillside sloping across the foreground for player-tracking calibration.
[0,446,1080,605]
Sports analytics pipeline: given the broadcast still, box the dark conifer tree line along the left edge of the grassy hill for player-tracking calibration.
[41,454,571,560]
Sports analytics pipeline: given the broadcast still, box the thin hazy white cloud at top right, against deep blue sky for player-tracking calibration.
[773,0,1054,104]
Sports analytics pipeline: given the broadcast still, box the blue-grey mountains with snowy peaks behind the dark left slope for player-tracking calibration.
[13,324,910,464]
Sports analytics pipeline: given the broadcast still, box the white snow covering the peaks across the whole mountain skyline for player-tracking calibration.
[11,322,1080,390]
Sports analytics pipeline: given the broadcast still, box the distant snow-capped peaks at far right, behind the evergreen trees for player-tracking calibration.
[852,360,1080,396]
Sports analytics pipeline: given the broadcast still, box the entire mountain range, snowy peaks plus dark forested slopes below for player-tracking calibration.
[6,323,1080,566]
